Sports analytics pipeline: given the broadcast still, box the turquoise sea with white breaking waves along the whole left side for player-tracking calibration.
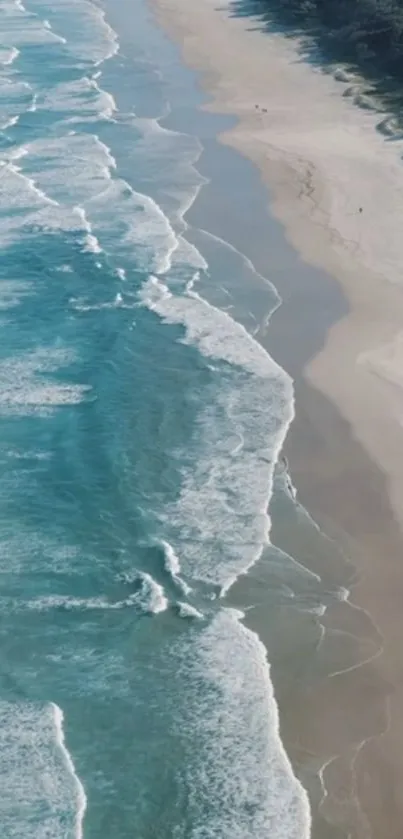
[0,0,318,839]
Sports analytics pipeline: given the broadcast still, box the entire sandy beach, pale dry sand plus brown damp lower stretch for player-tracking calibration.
[148,0,403,839]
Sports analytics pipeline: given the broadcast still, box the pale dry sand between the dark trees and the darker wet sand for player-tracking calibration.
[150,0,403,528]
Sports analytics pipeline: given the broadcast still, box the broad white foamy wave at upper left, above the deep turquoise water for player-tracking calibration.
[0,126,178,273]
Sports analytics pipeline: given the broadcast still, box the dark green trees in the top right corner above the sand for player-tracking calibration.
[234,0,403,79]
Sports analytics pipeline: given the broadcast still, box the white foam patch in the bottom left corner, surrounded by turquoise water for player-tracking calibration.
[0,702,86,839]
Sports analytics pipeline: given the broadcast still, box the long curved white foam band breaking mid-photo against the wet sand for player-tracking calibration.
[140,277,293,593]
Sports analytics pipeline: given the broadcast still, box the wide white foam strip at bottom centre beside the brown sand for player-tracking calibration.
[175,610,310,839]
